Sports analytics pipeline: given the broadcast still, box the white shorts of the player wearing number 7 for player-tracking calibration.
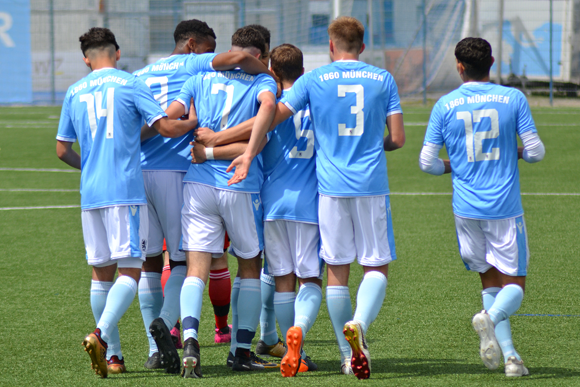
[181,183,264,259]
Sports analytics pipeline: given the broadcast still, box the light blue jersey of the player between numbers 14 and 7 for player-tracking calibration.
[133,54,217,172]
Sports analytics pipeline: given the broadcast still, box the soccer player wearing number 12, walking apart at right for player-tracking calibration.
[419,38,545,376]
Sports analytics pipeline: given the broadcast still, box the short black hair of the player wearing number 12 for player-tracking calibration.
[455,38,492,81]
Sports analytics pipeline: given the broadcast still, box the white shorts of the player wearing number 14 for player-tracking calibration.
[81,205,149,267]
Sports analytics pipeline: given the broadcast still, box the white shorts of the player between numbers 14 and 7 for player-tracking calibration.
[143,171,185,261]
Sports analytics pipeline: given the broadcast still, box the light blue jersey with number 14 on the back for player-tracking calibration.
[56,68,166,210]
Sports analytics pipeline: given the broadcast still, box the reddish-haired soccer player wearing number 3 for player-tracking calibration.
[228,17,405,379]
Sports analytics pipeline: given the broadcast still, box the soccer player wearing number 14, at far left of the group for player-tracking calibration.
[56,28,197,377]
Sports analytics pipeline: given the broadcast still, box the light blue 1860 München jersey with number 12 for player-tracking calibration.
[425,82,536,219]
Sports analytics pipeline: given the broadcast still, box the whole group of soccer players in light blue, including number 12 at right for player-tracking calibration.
[57,17,544,379]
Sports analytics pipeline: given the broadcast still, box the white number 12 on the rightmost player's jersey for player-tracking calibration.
[457,109,499,163]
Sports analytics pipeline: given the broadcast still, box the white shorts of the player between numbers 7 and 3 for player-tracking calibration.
[264,220,323,278]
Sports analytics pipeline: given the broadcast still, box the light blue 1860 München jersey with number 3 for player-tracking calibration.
[281,60,402,197]
